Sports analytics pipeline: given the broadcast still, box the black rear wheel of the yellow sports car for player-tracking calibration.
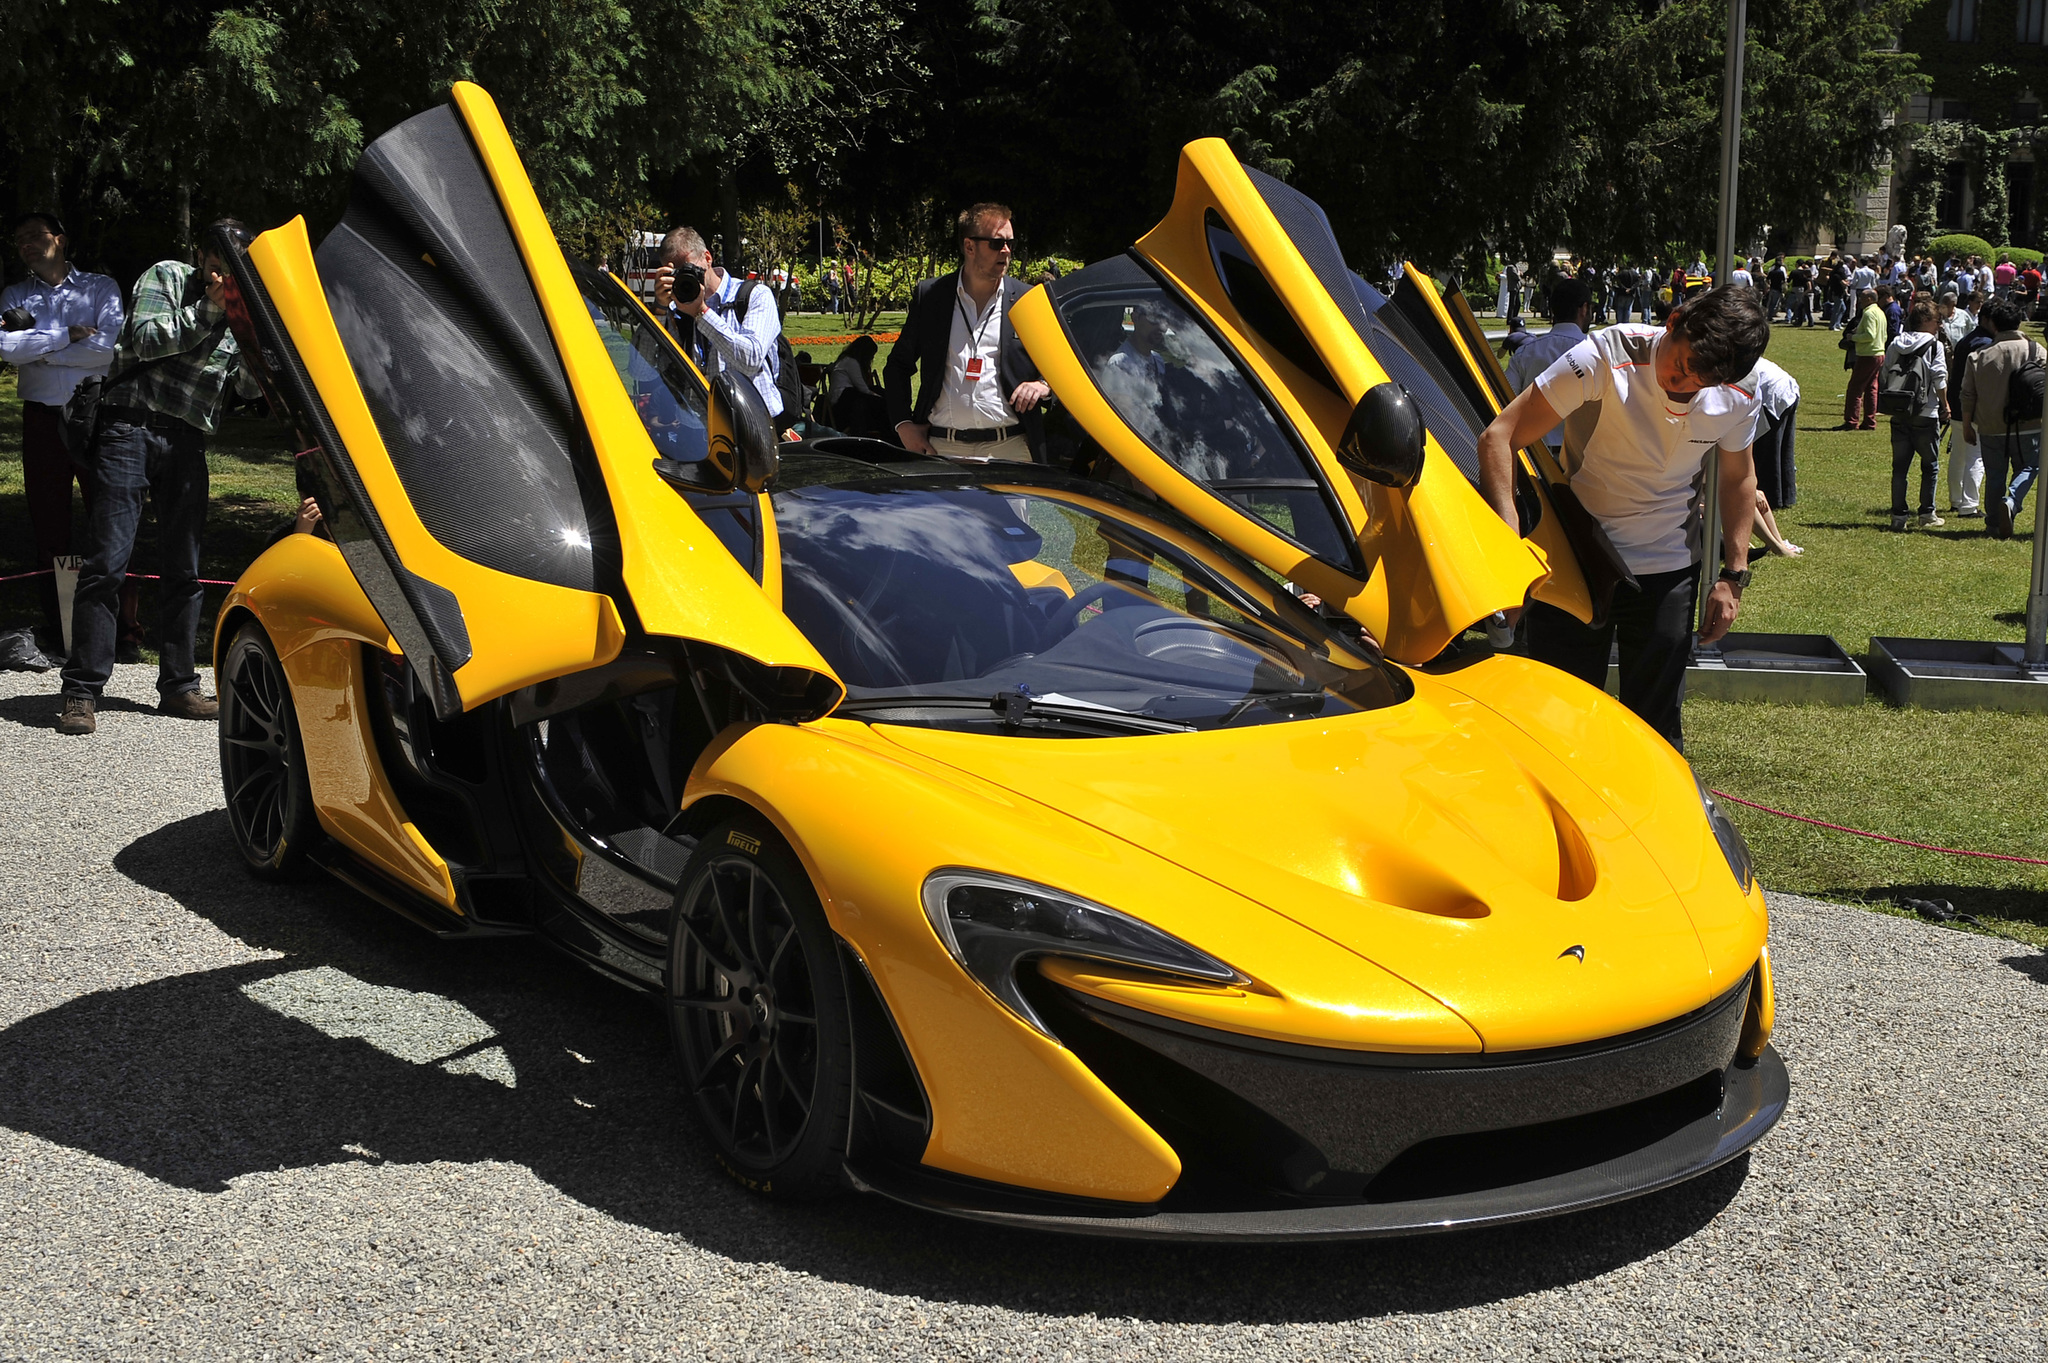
[219,622,319,880]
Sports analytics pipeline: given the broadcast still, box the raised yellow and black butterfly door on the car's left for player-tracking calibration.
[229,84,842,718]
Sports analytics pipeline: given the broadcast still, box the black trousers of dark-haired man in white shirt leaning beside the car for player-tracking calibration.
[1524,563,1700,753]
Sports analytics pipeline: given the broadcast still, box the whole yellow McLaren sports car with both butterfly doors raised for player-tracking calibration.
[211,84,1788,1238]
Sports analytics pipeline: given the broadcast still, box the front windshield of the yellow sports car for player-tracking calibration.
[772,477,1409,737]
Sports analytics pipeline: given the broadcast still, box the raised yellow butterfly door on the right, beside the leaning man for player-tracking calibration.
[1012,139,1546,663]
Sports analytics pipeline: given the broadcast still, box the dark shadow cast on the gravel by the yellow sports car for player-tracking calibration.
[0,812,1749,1322]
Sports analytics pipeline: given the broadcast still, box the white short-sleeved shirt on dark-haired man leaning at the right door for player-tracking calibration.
[1536,325,1763,575]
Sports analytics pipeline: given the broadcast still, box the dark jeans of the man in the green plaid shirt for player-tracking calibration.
[63,422,207,696]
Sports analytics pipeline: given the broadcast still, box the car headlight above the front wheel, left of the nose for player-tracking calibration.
[924,868,1245,1036]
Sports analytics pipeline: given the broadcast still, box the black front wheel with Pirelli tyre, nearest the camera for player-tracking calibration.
[668,819,852,1197]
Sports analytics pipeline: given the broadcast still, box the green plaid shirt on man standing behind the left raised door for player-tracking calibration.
[104,260,258,436]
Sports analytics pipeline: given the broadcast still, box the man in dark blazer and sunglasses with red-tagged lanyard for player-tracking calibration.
[883,203,1053,460]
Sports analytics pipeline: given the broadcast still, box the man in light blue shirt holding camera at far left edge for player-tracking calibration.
[0,213,141,663]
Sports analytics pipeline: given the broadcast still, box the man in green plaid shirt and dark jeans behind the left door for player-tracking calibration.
[57,217,260,735]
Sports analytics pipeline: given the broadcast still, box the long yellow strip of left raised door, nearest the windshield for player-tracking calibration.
[453,82,842,710]
